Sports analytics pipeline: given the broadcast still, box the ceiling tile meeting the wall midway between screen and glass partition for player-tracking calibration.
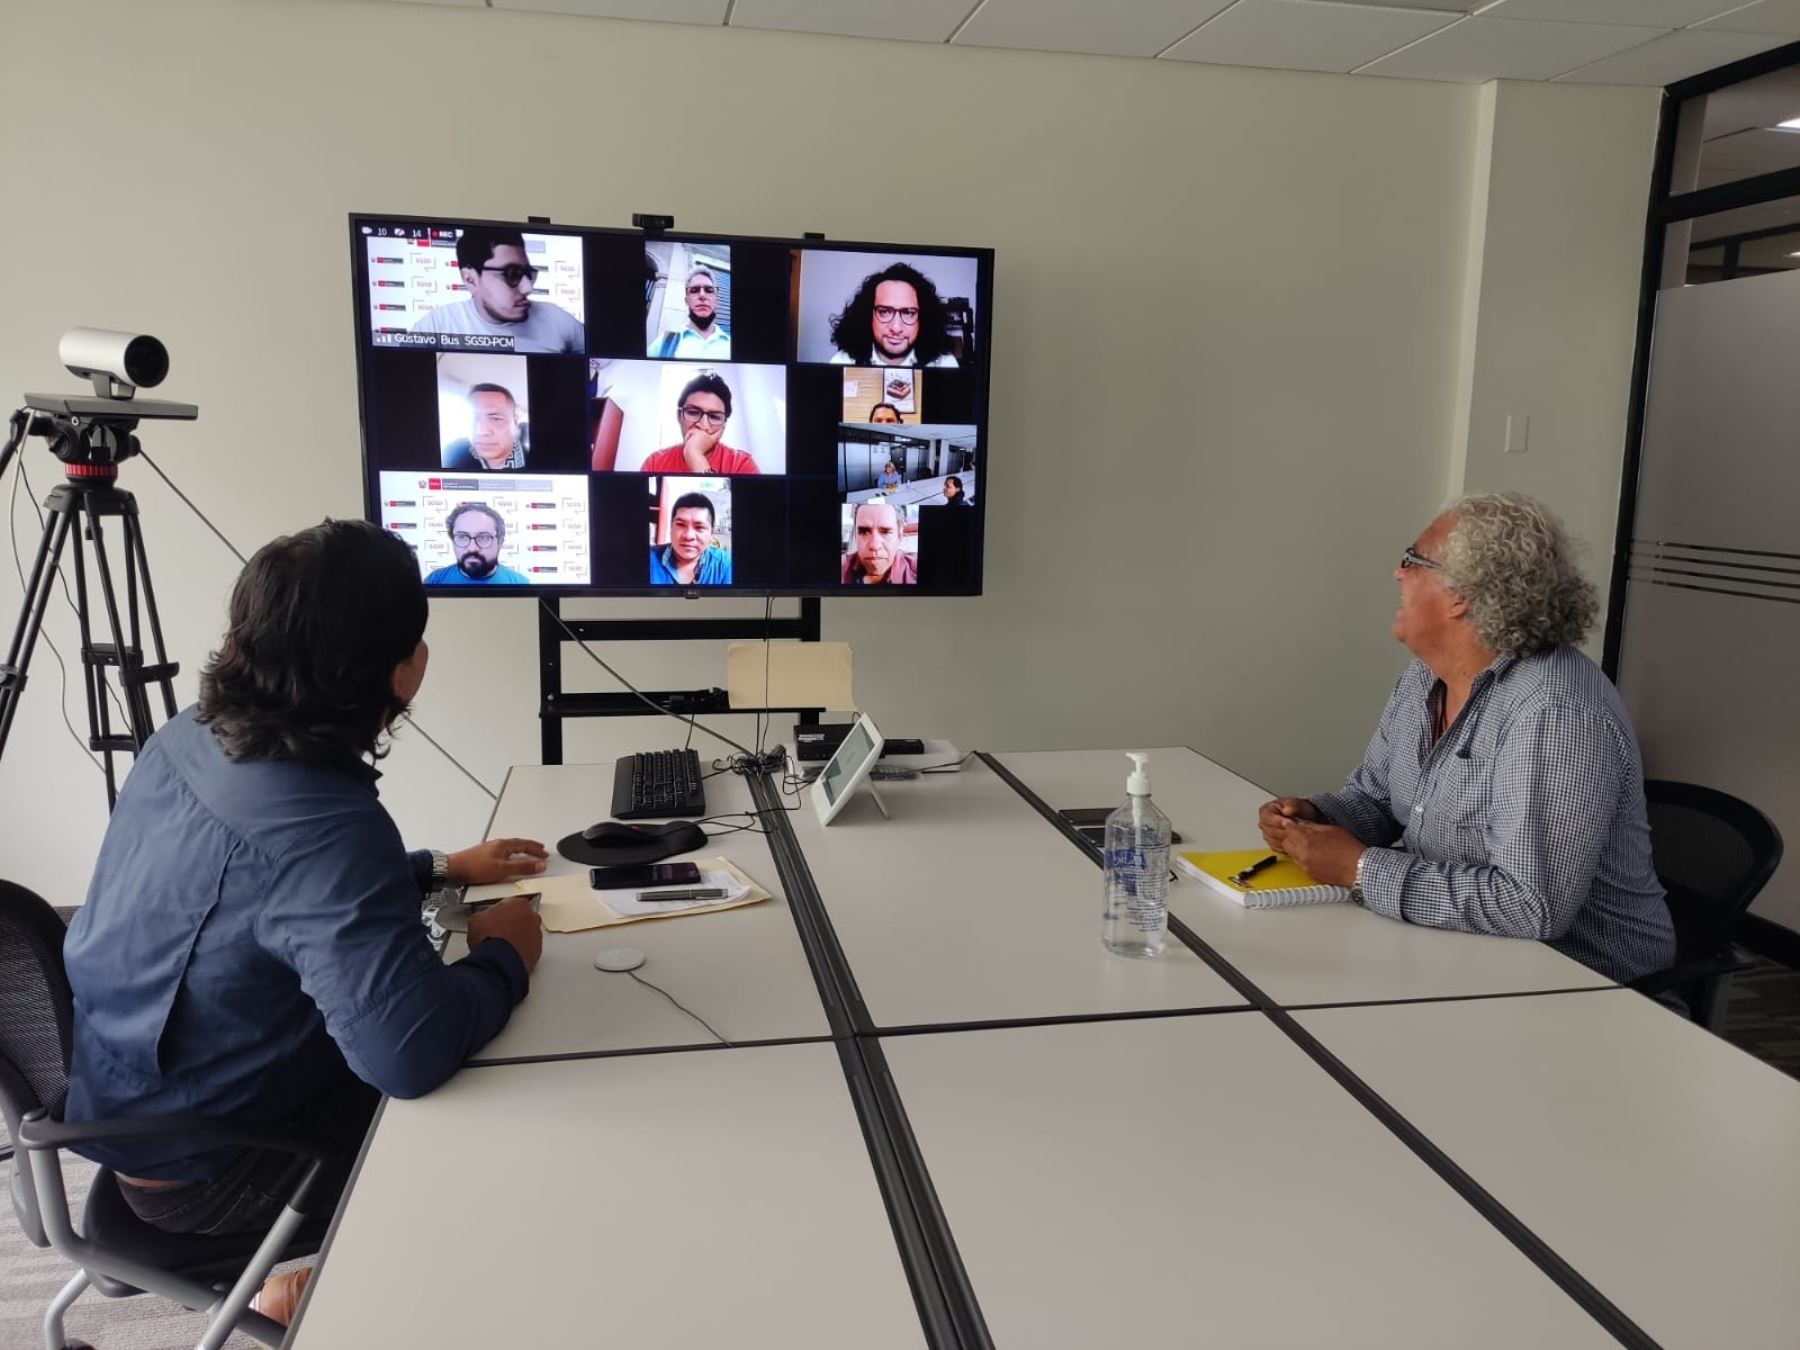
[1166,0,1456,70]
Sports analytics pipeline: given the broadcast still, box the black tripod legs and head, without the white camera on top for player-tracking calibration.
[0,406,180,810]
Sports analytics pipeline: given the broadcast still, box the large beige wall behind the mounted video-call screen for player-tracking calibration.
[0,0,1652,900]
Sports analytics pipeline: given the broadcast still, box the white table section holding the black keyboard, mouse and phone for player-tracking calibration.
[445,763,832,1064]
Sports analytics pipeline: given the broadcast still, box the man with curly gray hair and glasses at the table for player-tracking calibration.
[1258,493,1676,983]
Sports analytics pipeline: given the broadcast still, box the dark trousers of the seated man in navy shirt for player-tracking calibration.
[119,1080,382,1237]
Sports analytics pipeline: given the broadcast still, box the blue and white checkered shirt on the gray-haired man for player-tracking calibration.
[1312,646,1676,983]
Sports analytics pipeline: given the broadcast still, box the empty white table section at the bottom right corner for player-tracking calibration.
[1303,994,1800,1350]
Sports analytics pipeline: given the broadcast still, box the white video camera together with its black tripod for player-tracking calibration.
[0,328,200,806]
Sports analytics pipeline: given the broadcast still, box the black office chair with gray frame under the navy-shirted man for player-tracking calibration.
[0,882,331,1350]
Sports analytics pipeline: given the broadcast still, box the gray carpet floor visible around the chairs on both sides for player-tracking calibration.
[0,958,1800,1350]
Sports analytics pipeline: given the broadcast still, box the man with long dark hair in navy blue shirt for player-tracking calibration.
[63,520,545,1319]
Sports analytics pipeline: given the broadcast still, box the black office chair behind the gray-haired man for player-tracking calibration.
[1631,779,1782,1031]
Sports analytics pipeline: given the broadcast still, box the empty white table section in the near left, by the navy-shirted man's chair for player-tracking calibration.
[286,1044,923,1350]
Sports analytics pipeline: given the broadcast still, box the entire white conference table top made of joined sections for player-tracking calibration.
[290,724,1800,1350]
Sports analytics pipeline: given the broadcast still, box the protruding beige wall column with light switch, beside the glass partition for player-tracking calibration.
[1445,81,1661,657]
